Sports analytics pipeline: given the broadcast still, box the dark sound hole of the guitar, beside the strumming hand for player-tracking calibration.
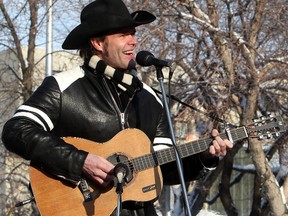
[107,153,133,187]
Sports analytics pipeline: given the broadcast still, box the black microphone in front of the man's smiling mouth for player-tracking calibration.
[136,50,172,67]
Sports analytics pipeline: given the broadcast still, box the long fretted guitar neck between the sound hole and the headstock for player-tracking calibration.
[130,127,248,172]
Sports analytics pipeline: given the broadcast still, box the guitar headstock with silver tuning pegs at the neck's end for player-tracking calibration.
[246,115,286,139]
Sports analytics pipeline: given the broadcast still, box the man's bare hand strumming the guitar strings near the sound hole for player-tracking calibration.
[83,153,114,188]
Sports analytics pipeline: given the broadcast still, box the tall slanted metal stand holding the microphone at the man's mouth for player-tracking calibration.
[156,66,191,216]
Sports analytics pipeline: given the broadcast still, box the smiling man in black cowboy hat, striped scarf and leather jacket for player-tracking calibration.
[2,0,232,215]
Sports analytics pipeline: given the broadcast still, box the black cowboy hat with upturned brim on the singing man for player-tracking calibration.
[62,0,156,49]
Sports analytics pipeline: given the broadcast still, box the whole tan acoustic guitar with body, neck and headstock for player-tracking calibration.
[30,116,284,216]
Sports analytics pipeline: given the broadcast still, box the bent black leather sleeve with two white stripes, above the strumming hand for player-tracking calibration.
[2,77,88,182]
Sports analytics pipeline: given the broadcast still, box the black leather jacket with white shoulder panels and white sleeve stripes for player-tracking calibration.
[2,67,210,182]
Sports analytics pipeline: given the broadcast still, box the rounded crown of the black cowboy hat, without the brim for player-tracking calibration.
[80,0,132,23]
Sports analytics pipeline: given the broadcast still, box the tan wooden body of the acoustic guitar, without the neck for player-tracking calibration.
[30,129,163,216]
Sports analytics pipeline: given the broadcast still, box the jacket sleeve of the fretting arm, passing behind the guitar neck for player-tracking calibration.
[154,107,219,185]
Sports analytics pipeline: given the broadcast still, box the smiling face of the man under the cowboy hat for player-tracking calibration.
[94,28,137,69]
